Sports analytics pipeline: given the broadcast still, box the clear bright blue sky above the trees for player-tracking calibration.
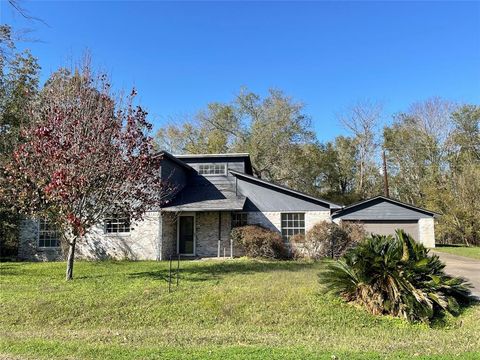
[0,0,480,141]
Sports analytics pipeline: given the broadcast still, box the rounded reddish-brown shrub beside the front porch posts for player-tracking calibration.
[231,225,288,259]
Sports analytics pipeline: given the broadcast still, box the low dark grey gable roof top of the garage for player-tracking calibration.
[332,196,440,220]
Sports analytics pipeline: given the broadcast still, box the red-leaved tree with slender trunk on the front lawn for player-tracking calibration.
[0,65,172,280]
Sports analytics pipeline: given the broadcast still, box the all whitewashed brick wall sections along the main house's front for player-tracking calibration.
[19,211,338,261]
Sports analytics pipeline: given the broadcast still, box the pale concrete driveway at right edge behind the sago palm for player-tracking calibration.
[431,250,480,298]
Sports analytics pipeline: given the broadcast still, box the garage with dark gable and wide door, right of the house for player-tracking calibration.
[332,196,438,248]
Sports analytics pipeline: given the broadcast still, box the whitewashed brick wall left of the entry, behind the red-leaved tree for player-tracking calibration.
[19,212,160,261]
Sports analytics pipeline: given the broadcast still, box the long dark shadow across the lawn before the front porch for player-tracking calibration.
[128,261,314,282]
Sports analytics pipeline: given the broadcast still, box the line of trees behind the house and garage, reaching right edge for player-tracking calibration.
[157,89,480,245]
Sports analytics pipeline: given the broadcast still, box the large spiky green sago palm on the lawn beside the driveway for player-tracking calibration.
[320,230,470,322]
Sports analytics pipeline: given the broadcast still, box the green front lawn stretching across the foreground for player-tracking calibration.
[0,259,480,360]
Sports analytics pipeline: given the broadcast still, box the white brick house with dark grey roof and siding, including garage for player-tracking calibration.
[19,152,435,260]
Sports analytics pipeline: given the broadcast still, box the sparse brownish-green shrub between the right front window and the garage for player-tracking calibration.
[290,221,366,259]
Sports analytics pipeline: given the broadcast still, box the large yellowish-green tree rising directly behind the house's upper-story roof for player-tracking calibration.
[157,89,316,190]
